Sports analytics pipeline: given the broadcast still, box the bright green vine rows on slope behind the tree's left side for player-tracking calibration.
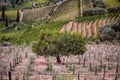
[12,21,66,45]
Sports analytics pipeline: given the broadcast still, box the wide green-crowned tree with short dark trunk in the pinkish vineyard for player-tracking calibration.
[33,32,86,63]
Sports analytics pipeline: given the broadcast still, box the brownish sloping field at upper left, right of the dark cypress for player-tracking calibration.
[23,5,56,22]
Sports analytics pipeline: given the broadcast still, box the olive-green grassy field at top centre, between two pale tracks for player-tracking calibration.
[52,0,79,21]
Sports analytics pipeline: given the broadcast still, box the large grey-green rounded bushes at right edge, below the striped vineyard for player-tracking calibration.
[99,22,120,40]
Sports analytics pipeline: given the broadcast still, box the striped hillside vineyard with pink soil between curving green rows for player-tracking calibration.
[60,13,120,38]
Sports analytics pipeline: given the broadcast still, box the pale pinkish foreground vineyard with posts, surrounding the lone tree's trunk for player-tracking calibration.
[0,43,120,80]
